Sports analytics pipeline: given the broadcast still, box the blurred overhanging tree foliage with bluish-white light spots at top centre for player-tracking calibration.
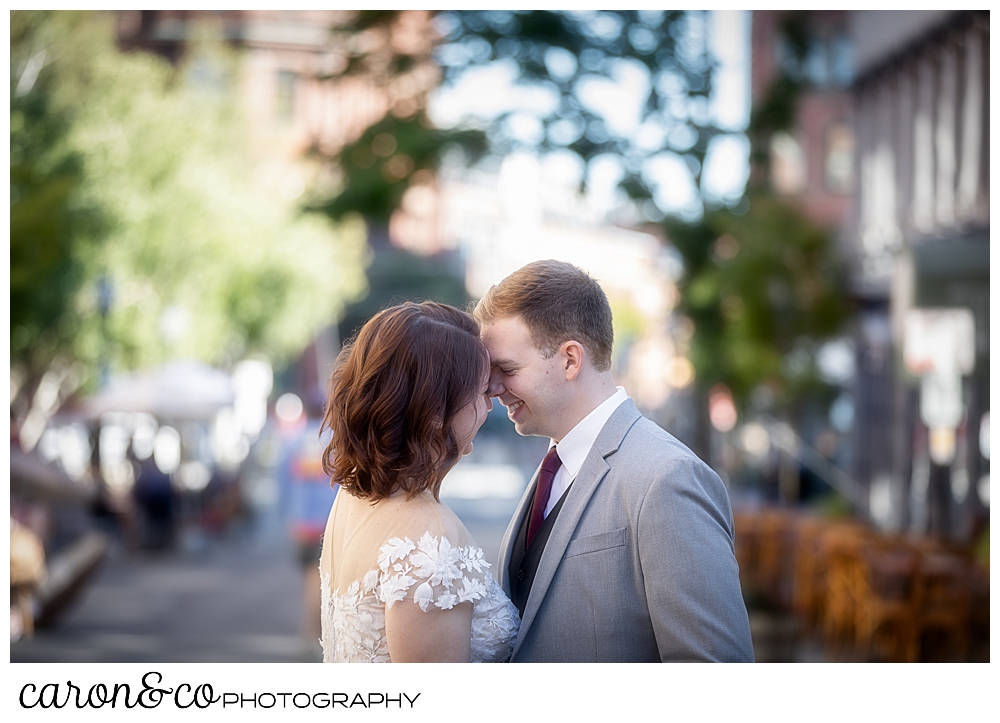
[327,10,717,219]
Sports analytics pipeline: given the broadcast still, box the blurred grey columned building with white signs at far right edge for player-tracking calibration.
[845,11,989,541]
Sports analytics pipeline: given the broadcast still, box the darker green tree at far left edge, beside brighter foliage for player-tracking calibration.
[10,12,108,412]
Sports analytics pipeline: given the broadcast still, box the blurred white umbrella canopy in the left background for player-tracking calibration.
[84,360,234,419]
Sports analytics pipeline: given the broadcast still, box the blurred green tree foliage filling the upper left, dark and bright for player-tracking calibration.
[11,11,364,416]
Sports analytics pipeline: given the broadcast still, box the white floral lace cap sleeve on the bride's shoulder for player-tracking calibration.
[378,532,490,612]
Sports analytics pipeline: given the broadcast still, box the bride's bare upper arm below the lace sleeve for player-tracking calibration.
[385,600,472,663]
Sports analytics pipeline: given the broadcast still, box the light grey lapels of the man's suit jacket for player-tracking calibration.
[504,399,641,656]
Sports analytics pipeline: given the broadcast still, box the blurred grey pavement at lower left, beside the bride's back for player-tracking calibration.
[10,510,320,663]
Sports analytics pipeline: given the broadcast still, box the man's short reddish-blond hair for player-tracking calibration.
[472,260,615,371]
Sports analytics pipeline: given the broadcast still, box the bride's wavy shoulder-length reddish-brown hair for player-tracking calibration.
[323,301,489,502]
